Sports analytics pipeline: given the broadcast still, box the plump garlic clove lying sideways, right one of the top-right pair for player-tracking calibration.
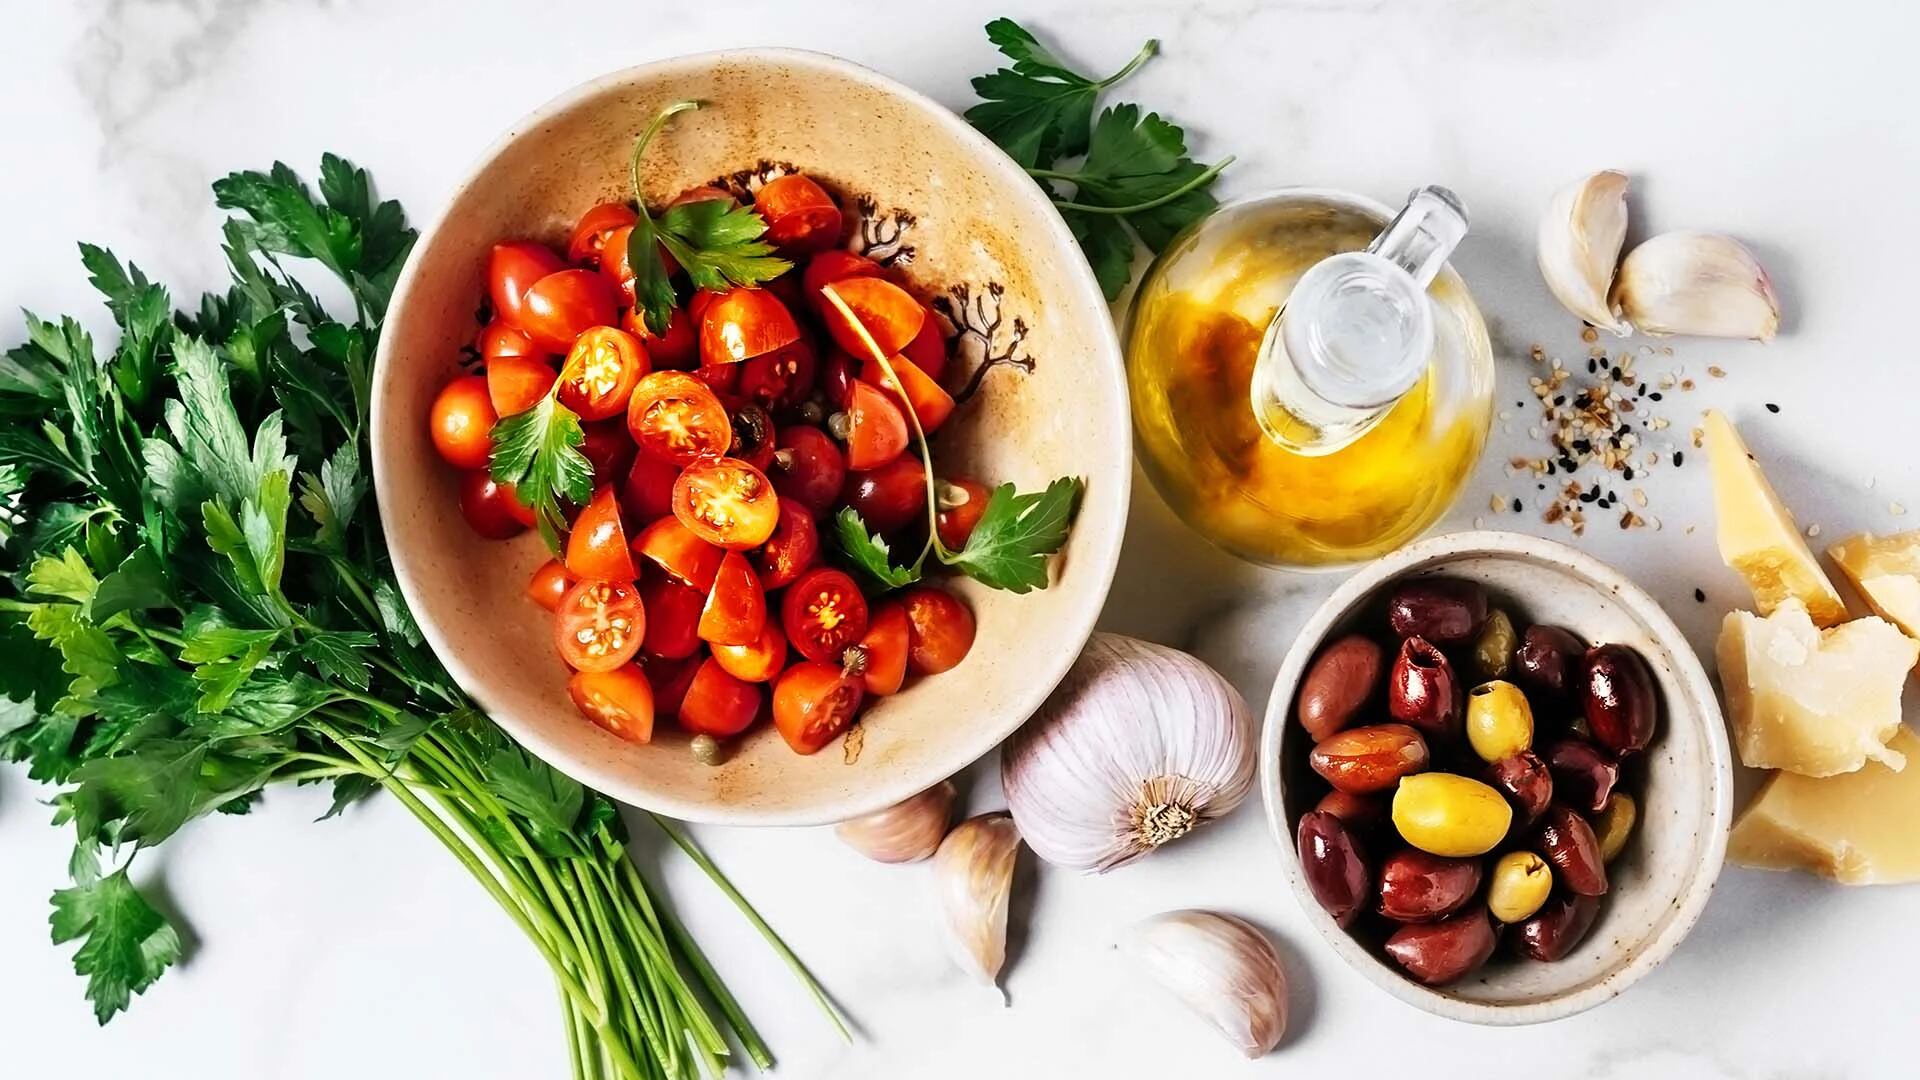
[1613,233,1780,342]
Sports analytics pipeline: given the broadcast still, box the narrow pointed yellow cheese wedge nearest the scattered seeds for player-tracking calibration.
[1705,411,1847,626]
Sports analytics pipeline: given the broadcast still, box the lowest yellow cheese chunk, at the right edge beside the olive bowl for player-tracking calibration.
[1726,728,1920,886]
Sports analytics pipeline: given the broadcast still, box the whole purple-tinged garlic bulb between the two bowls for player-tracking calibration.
[1000,634,1254,871]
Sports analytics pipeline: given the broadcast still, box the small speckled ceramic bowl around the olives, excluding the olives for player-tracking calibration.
[1260,532,1732,1024]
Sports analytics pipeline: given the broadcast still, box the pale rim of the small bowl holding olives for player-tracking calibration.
[1260,530,1734,1026]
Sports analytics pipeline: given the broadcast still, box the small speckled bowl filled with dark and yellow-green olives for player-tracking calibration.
[1260,532,1732,1024]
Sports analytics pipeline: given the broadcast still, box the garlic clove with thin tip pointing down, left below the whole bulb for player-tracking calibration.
[933,813,1020,986]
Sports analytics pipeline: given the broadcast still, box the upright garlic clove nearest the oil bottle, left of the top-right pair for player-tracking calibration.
[1536,169,1630,336]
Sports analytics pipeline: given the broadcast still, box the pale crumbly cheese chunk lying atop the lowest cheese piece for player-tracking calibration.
[1716,600,1920,776]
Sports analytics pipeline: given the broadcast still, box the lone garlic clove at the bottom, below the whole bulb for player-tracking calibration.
[1119,911,1286,1057]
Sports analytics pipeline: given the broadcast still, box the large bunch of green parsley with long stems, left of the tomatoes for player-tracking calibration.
[0,156,839,1080]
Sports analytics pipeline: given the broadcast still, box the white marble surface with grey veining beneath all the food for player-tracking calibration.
[0,0,1920,1080]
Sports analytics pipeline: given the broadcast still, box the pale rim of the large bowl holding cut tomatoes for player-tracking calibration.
[369,46,1133,826]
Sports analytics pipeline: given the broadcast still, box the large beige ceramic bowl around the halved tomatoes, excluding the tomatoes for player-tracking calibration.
[372,50,1131,824]
